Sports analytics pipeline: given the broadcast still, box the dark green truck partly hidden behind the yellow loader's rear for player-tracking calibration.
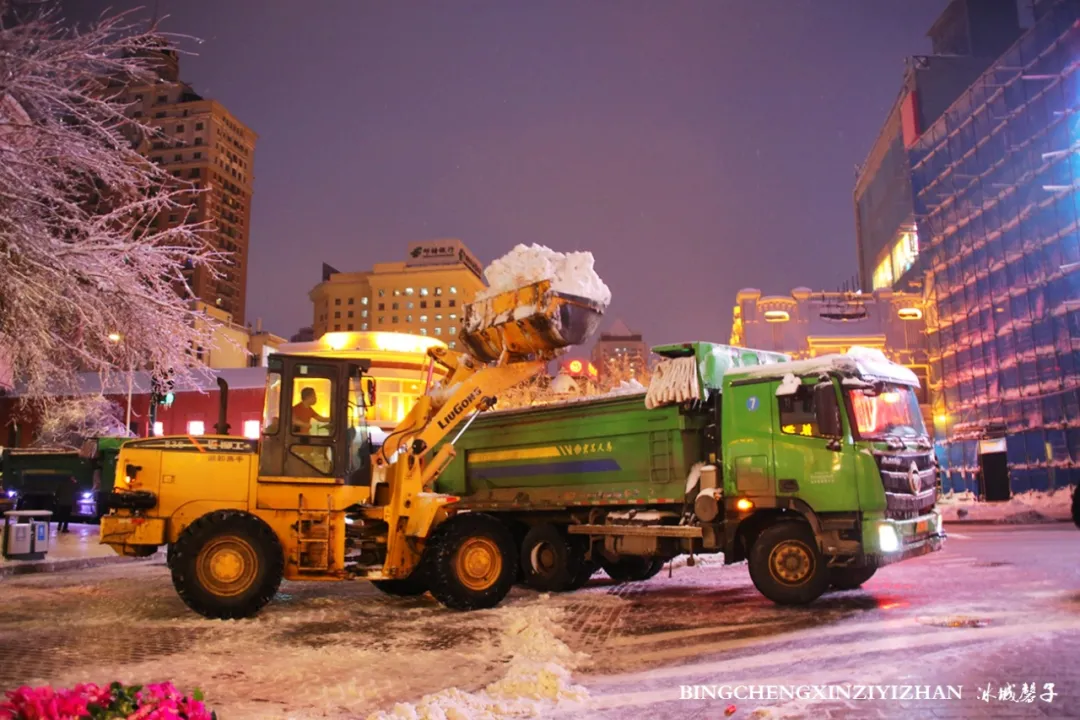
[0,437,127,520]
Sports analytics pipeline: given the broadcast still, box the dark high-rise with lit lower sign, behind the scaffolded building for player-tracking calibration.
[854,0,1020,291]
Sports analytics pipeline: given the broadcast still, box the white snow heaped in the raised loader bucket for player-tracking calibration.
[476,244,611,308]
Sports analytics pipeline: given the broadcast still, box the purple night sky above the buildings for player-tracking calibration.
[65,0,980,344]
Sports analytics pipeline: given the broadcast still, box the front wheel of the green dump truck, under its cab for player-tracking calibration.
[750,522,828,604]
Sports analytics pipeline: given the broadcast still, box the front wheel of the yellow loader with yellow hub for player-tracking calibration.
[424,513,517,610]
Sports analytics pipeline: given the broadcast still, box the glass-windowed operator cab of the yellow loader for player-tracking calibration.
[259,354,375,485]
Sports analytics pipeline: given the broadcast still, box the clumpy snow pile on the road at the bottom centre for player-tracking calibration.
[368,596,589,720]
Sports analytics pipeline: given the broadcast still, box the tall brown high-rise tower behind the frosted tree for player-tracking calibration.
[124,39,257,324]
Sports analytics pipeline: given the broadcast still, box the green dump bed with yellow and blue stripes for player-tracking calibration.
[436,394,705,511]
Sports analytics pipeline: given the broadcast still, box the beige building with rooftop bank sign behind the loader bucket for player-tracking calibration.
[309,240,487,348]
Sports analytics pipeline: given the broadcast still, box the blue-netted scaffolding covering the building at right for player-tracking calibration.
[909,0,1080,492]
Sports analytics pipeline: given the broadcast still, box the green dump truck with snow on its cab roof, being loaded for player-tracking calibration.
[436,342,945,604]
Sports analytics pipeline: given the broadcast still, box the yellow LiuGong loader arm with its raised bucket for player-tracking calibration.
[373,281,604,579]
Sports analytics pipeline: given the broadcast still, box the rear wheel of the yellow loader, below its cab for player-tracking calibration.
[168,511,285,620]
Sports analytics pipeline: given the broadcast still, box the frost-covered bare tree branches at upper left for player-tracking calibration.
[0,0,224,406]
